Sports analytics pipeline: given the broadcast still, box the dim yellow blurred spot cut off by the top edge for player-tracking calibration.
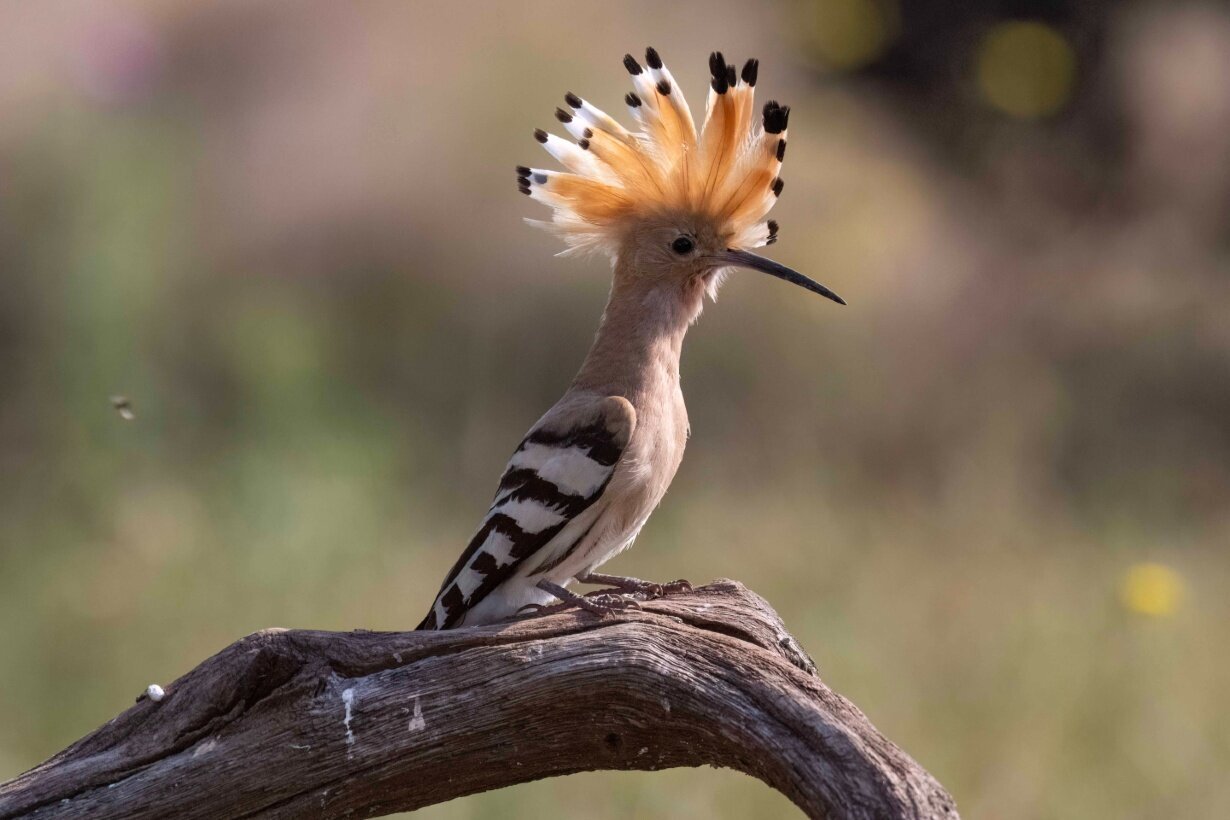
[803,0,898,71]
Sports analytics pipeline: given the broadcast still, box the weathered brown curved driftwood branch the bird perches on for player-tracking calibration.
[0,581,957,819]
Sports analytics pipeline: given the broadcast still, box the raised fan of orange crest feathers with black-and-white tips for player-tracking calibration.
[517,48,790,254]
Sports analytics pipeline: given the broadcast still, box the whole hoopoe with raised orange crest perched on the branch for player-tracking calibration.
[417,47,845,629]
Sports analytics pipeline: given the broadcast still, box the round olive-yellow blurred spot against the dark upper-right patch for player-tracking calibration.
[977,21,1076,119]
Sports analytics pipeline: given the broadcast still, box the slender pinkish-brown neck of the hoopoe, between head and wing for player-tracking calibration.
[573,264,702,409]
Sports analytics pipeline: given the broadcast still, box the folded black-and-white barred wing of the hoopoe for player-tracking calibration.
[418,396,636,629]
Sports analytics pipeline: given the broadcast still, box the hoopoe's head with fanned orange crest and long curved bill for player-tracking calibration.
[517,48,845,305]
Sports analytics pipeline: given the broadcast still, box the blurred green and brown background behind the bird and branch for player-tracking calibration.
[0,0,1230,820]
